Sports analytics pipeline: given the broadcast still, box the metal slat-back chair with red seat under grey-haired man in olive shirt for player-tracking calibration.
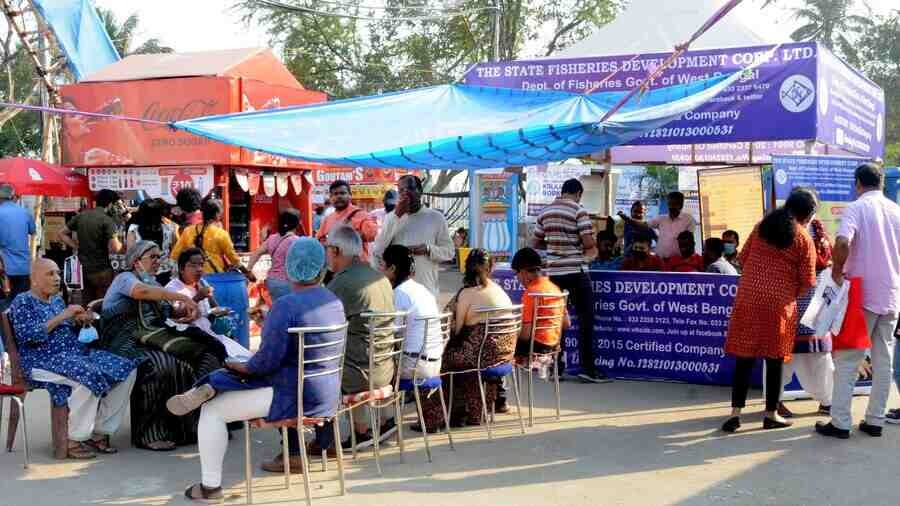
[338,311,409,475]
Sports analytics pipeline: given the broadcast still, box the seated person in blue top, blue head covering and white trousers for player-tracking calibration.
[167,237,345,501]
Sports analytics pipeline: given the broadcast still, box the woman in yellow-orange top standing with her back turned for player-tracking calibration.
[171,199,256,281]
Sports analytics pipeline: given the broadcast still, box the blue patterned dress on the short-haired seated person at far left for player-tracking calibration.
[10,292,135,406]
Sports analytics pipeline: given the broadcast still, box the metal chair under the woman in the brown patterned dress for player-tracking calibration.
[447,304,525,440]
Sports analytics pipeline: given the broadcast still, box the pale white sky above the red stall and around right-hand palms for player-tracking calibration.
[102,0,897,56]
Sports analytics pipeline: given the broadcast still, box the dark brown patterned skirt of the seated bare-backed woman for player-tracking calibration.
[422,324,517,431]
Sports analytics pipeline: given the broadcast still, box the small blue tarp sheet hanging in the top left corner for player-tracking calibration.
[33,0,119,81]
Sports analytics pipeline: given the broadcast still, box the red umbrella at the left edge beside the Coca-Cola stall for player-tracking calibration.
[0,158,93,198]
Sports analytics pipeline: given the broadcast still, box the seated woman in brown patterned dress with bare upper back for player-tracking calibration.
[412,248,510,432]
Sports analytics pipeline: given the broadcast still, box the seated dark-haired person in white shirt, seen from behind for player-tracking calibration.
[381,244,444,383]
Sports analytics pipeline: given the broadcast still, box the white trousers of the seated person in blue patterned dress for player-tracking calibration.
[31,369,137,441]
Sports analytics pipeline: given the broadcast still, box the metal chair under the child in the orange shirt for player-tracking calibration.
[513,291,569,427]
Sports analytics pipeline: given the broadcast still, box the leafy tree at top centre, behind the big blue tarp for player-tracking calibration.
[235,0,622,193]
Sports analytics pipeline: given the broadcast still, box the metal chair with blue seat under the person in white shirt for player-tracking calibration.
[400,313,455,462]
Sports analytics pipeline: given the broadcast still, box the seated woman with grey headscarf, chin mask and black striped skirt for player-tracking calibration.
[98,241,224,451]
